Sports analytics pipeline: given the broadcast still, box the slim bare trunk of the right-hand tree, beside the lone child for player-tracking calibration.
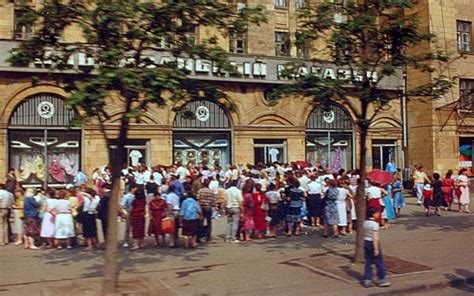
[354,127,367,263]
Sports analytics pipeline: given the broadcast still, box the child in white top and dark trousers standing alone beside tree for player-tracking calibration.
[363,207,391,288]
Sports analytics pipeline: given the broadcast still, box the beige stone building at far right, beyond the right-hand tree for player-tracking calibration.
[408,0,474,173]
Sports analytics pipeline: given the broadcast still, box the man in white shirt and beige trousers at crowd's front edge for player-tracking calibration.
[225,180,244,243]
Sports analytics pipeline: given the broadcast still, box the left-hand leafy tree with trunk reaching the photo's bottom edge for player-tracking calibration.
[10,0,264,293]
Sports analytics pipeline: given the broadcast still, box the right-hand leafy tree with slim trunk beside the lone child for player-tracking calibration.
[273,0,452,262]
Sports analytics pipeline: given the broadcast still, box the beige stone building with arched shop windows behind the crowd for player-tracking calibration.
[0,0,404,184]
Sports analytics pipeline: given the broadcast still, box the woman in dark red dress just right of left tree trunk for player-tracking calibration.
[130,190,146,250]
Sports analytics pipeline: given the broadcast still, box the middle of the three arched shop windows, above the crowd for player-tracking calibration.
[173,100,232,166]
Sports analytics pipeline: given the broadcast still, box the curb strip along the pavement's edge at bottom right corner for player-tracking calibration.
[367,276,474,296]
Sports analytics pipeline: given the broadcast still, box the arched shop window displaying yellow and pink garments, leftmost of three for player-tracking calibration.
[8,93,81,186]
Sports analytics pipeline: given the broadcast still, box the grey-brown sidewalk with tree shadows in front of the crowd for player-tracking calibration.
[0,198,474,295]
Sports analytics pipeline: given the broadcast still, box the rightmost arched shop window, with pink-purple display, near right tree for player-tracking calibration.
[306,104,354,171]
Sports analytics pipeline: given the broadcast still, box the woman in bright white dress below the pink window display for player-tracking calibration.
[52,189,76,250]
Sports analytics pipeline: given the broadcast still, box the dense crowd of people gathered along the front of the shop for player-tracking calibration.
[0,163,469,250]
